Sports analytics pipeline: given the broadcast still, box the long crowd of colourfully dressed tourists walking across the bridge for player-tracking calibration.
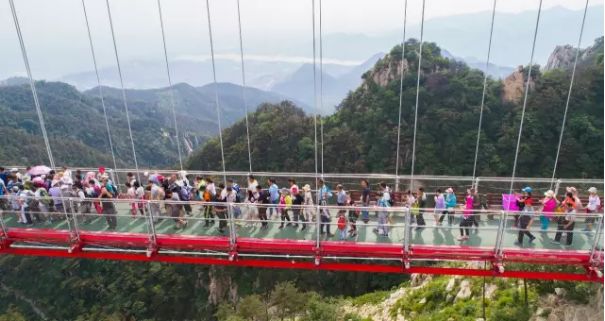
[0,166,602,245]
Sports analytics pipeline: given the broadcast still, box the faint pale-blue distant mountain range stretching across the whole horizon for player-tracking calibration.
[0,3,603,83]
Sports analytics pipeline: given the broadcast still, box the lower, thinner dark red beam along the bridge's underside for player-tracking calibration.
[0,248,603,283]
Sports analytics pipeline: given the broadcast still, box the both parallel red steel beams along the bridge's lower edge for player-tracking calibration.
[0,228,603,283]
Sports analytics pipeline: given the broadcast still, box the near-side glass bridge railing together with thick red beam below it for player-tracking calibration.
[0,196,603,266]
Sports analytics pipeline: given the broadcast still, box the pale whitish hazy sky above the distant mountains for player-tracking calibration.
[0,0,603,77]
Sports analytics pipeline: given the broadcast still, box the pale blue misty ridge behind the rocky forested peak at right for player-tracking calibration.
[308,5,603,67]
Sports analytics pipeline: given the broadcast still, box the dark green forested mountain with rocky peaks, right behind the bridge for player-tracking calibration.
[188,38,603,178]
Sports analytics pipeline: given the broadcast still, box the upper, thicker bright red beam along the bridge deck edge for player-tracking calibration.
[3,228,603,276]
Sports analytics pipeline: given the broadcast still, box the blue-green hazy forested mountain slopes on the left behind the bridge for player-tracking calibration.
[0,78,285,167]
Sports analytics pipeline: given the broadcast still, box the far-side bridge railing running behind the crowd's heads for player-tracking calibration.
[4,166,605,196]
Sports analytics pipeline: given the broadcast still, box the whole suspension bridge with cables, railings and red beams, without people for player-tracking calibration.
[0,0,604,282]
